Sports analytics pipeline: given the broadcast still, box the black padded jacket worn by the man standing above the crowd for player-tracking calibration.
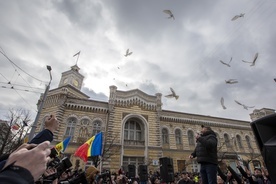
[191,131,218,165]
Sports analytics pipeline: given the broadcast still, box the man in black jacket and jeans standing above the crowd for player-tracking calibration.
[189,126,218,184]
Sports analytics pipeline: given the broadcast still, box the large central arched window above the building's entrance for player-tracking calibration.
[124,119,142,141]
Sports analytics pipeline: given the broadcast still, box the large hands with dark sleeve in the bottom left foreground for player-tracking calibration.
[0,141,51,184]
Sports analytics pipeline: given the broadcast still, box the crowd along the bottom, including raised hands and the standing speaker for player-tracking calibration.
[0,115,272,184]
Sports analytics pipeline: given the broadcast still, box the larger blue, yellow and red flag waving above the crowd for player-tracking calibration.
[75,132,103,162]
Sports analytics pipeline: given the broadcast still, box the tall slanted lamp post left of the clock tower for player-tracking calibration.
[29,65,52,141]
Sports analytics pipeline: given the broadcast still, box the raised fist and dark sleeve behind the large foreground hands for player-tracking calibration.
[29,114,59,144]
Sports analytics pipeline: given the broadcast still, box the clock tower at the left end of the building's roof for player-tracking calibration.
[58,65,84,90]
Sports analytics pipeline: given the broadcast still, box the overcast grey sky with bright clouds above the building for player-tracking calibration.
[0,0,276,121]
